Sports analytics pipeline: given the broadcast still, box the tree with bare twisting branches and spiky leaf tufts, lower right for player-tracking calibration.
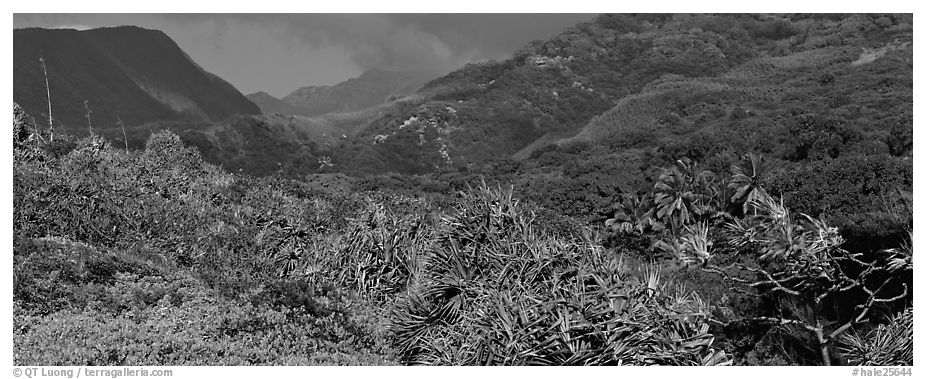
[704,191,912,365]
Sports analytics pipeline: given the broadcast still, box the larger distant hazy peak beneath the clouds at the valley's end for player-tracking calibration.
[280,69,438,116]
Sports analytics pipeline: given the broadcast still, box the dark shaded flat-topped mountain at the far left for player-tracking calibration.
[13,26,260,134]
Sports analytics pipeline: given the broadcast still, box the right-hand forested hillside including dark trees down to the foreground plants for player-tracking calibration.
[334,14,913,264]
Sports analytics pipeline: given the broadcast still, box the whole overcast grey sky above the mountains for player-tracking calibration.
[13,14,593,97]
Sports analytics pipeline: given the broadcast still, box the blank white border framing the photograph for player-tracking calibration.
[0,0,926,379]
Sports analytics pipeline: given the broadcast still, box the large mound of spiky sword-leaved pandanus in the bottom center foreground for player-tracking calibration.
[392,184,729,365]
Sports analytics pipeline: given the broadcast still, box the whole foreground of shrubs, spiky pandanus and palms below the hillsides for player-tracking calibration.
[13,102,913,366]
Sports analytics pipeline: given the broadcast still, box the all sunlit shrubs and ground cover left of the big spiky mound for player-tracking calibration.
[13,121,398,365]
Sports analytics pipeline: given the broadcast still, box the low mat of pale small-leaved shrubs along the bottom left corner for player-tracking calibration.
[13,287,389,366]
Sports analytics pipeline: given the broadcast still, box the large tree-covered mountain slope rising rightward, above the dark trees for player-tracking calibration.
[333,14,912,174]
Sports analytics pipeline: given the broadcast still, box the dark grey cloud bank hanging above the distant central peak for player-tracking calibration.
[218,14,592,70]
